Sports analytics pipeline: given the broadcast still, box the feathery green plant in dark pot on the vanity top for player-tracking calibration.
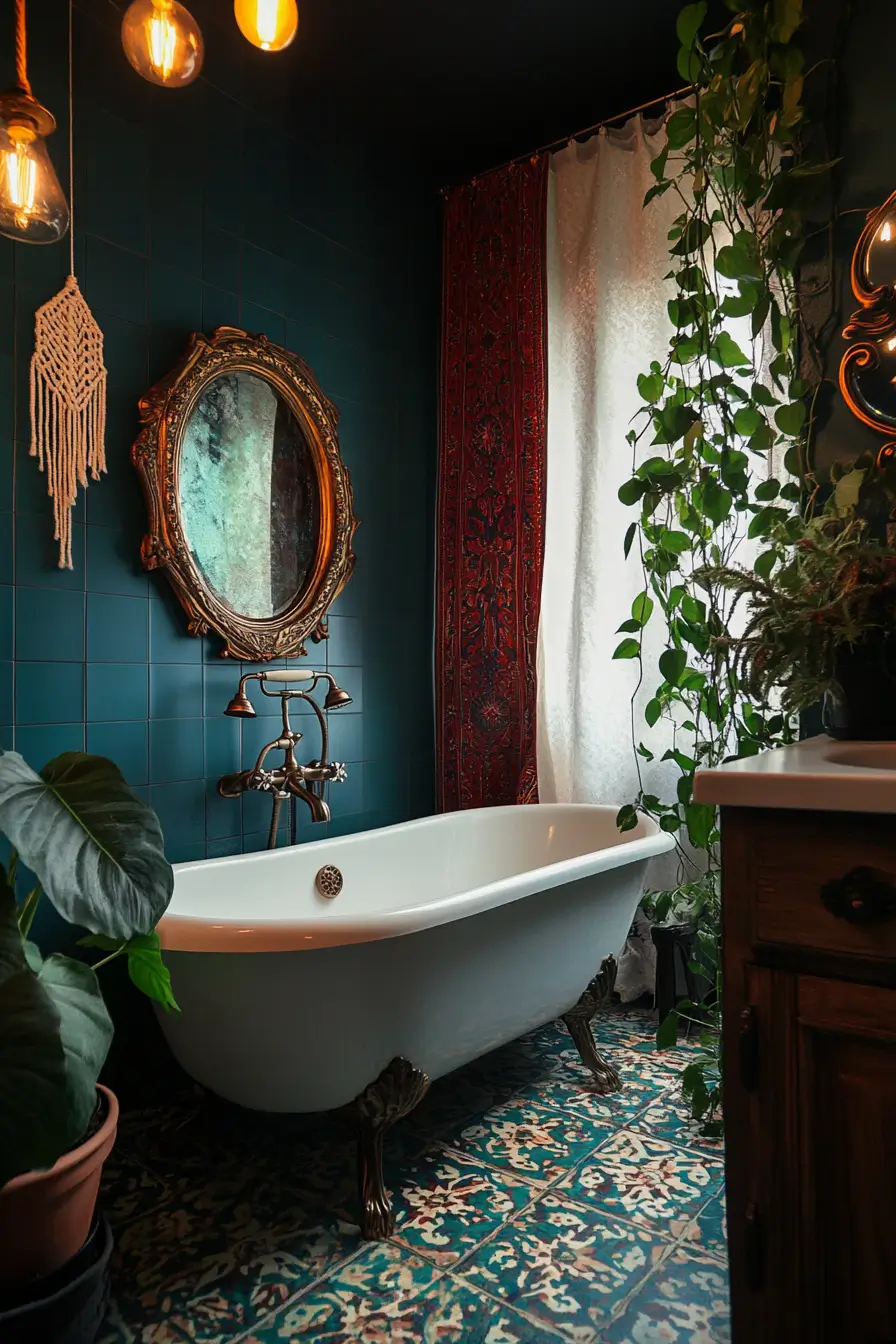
[699,457,896,741]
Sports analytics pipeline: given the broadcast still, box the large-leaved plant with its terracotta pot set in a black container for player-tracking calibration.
[0,751,176,1344]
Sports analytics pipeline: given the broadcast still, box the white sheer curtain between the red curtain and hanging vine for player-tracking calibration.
[537,117,680,999]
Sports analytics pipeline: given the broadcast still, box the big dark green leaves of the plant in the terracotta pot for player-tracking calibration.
[0,751,177,1187]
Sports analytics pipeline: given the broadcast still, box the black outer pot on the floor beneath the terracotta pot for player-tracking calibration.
[0,1214,113,1344]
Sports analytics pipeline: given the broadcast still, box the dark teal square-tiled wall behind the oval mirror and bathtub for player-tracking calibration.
[0,0,439,860]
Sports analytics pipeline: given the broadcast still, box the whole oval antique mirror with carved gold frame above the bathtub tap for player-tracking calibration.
[132,327,357,661]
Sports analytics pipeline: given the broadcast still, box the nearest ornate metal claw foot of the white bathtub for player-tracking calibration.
[355,1055,430,1242]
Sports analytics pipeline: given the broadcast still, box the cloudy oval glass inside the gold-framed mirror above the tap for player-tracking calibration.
[179,370,320,620]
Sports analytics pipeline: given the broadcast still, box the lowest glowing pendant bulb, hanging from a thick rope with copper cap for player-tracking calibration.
[0,89,69,243]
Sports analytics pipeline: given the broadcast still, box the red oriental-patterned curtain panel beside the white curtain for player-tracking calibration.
[435,155,548,810]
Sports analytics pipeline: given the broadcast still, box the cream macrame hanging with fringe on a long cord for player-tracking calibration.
[31,0,106,570]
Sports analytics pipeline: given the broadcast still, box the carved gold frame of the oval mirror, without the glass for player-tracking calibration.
[130,327,357,661]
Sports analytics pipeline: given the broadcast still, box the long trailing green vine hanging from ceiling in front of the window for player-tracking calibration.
[614,0,830,1130]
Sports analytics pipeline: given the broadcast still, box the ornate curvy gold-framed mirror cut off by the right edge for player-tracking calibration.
[840,191,896,465]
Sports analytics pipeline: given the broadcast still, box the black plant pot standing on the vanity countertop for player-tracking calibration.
[822,630,896,742]
